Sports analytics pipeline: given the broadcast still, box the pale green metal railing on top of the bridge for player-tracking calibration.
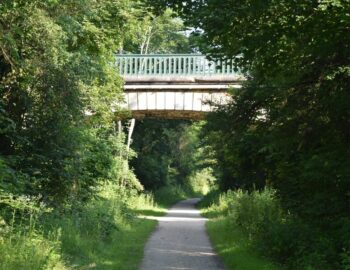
[116,54,239,75]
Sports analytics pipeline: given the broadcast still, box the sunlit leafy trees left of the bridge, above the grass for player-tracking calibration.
[0,0,142,202]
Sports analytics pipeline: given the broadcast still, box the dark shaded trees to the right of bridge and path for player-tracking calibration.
[149,0,350,269]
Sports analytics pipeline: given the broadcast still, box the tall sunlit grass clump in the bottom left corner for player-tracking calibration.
[0,195,70,270]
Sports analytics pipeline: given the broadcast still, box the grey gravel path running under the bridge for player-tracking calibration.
[140,199,224,270]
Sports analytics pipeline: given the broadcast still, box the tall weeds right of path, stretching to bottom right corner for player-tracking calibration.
[201,188,350,270]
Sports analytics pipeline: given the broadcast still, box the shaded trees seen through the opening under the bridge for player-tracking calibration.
[131,119,211,189]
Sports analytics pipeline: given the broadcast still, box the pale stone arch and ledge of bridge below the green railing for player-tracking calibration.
[119,74,242,120]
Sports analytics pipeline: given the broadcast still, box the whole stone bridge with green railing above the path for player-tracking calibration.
[116,54,244,119]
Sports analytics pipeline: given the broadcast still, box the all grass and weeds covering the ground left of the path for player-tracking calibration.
[0,183,159,270]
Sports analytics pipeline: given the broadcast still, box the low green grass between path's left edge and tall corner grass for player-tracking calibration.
[54,192,165,270]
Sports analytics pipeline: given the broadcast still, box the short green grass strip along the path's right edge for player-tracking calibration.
[206,218,280,270]
